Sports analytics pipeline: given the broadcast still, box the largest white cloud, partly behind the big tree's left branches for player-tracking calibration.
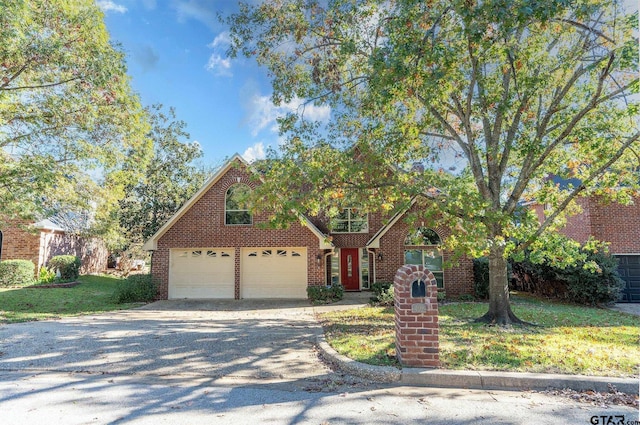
[247,95,331,137]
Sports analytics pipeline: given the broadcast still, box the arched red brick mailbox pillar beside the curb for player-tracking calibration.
[393,265,440,367]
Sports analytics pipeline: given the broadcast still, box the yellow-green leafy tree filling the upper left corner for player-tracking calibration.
[0,0,151,232]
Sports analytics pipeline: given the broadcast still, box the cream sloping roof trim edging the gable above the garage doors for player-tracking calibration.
[142,153,333,251]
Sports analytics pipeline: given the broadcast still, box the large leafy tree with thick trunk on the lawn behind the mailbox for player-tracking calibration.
[228,0,640,324]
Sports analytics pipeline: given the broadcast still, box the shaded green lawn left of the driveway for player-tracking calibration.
[0,275,141,323]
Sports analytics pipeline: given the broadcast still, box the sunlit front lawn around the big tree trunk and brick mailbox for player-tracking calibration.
[321,297,640,377]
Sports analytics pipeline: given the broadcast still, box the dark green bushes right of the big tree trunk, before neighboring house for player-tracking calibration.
[513,246,624,305]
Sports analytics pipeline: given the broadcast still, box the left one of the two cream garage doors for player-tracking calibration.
[169,248,235,299]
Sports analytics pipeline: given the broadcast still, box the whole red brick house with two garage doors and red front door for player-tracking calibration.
[144,155,473,299]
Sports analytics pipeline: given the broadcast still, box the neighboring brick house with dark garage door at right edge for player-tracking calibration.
[535,197,640,302]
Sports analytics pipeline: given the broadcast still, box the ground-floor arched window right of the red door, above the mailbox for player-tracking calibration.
[404,227,444,288]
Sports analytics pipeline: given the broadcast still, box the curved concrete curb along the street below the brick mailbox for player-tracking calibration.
[317,335,640,394]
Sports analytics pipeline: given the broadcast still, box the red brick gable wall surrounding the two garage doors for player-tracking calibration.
[151,162,325,299]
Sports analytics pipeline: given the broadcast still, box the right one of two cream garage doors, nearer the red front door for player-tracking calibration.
[240,248,307,298]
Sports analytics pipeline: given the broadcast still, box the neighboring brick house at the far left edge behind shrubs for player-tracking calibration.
[0,220,108,274]
